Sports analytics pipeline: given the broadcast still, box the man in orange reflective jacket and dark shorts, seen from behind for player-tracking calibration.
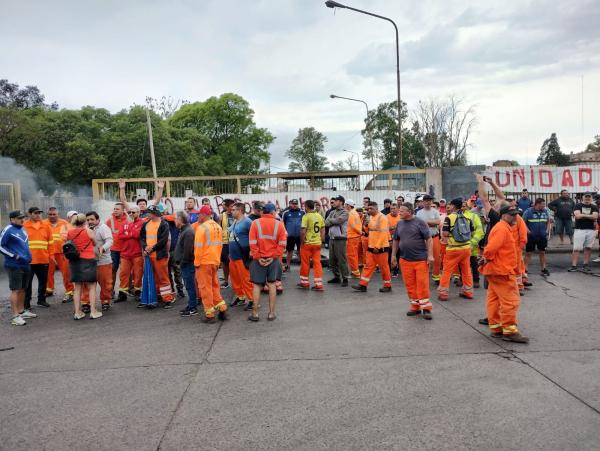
[248,203,287,322]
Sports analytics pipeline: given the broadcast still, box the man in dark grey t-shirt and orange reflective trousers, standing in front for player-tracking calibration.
[392,202,434,320]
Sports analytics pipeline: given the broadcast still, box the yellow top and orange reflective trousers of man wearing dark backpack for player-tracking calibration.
[438,213,474,301]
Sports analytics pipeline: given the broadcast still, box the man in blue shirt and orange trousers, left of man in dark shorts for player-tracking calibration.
[229,202,253,307]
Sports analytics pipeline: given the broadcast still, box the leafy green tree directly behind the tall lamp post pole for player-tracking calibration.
[361,101,425,170]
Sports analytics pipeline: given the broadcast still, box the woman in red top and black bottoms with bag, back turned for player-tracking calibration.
[63,213,102,320]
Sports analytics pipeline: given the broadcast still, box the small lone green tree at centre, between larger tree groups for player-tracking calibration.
[285,127,328,172]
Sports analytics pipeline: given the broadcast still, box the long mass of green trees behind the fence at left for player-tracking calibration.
[0,80,274,191]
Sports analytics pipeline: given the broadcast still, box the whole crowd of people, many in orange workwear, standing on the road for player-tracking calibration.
[0,175,600,343]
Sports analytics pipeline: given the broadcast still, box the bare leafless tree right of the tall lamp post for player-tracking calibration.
[412,96,477,168]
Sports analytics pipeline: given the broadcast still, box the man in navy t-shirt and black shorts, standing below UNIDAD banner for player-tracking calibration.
[523,197,550,276]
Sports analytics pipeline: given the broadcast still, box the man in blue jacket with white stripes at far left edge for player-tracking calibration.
[0,210,37,326]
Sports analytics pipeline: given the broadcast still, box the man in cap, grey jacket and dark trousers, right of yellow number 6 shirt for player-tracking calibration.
[325,196,349,287]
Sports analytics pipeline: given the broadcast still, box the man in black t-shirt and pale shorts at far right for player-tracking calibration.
[569,193,598,272]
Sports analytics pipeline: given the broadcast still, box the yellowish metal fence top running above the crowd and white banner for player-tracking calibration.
[92,169,427,202]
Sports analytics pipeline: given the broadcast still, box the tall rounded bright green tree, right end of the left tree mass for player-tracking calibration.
[168,94,275,175]
